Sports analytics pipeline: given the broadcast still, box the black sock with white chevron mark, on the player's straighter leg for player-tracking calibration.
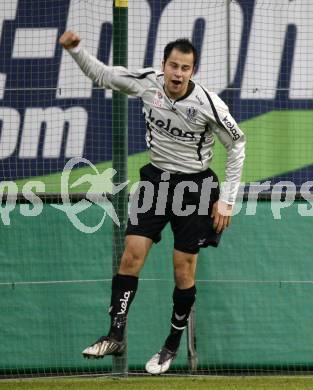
[164,286,197,352]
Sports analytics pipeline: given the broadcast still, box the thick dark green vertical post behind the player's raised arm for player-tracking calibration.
[112,0,128,375]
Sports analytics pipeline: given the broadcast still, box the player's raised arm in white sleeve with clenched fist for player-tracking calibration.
[59,31,146,96]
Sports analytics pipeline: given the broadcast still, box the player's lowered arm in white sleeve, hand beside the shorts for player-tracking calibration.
[208,96,245,232]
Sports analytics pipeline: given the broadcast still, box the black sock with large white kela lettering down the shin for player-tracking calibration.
[108,274,138,341]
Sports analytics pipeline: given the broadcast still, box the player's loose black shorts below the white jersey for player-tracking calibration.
[126,164,221,254]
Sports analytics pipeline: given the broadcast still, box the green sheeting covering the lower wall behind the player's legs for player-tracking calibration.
[0,203,313,374]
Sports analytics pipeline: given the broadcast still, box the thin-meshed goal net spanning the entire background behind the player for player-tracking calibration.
[0,0,313,376]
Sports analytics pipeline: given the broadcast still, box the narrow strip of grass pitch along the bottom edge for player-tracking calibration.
[0,376,313,390]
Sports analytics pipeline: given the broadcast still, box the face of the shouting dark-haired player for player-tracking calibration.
[162,49,194,100]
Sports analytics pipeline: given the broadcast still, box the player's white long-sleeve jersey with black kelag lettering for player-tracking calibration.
[70,46,245,204]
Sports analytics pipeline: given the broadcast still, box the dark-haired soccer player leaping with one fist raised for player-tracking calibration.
[60,31,245,374]
